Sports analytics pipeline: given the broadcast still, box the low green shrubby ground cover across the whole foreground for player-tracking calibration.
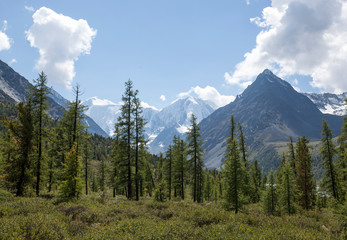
[0,190,343,239]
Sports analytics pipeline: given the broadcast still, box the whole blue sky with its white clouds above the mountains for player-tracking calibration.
[0,0,347,109]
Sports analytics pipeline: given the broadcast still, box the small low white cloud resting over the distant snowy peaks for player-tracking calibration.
[178,86,235,108]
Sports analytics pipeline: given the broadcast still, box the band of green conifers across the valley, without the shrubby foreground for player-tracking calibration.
[0,73,347,215]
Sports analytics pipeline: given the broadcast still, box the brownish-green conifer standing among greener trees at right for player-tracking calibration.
[295,137,315,210]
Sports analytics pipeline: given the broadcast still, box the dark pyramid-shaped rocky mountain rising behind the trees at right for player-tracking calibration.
[200,69,342,171]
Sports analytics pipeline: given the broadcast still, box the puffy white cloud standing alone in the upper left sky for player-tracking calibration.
[26,7,96,89]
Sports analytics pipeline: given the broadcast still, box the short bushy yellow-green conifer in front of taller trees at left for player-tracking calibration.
[60,143,82,199]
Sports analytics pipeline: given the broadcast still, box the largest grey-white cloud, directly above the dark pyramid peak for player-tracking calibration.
[225,0,347,93]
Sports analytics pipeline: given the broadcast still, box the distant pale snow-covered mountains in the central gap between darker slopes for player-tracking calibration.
[83,96,214,153]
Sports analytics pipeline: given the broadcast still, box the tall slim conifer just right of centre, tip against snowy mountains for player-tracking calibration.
[187,114,204,203]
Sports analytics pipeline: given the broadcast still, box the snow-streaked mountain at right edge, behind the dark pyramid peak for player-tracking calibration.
[304,92,347,116]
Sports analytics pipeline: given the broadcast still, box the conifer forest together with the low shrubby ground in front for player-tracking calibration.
[0,72,347,239]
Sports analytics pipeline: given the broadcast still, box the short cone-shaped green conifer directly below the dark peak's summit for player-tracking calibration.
[263,169,278,215]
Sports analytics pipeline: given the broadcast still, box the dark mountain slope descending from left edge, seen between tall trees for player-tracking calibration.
[0,60,108,137]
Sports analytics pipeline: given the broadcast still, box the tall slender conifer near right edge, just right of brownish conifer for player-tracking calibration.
[321,119,339,200]
